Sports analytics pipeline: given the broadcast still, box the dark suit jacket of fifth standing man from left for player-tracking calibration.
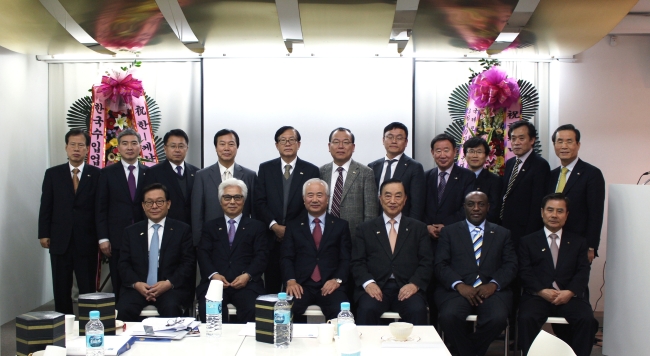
[255,157,319,227]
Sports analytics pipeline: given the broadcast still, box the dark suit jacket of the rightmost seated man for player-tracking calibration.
[519,229,591,299]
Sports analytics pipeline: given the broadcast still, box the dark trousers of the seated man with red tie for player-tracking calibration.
[292,284,348,323]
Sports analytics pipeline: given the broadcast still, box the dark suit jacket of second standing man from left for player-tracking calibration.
[96,162,148,250]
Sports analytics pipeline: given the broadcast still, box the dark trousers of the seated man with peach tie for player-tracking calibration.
[356,279,427,325]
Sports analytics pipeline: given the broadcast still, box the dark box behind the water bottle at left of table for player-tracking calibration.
[79,293,115,336]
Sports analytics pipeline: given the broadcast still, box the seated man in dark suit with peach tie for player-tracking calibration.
[352,179,433,325]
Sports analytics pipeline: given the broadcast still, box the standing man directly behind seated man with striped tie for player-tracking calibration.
[463,137,503,224]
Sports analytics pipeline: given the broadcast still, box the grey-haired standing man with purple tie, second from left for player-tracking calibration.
[96,128,147,302]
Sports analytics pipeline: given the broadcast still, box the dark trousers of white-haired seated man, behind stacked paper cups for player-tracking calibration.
[197,287,259,323]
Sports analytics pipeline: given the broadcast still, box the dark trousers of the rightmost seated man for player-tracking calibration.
[518,293,598,356]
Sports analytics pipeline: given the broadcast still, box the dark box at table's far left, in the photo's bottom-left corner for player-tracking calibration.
[16,311,65,356]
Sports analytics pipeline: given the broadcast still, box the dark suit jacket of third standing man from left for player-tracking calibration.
[142,160,199,225]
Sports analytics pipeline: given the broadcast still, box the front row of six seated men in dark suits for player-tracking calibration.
[117,178,598,356]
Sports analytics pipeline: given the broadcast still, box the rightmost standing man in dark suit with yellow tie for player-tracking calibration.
[547,124,605,263]
